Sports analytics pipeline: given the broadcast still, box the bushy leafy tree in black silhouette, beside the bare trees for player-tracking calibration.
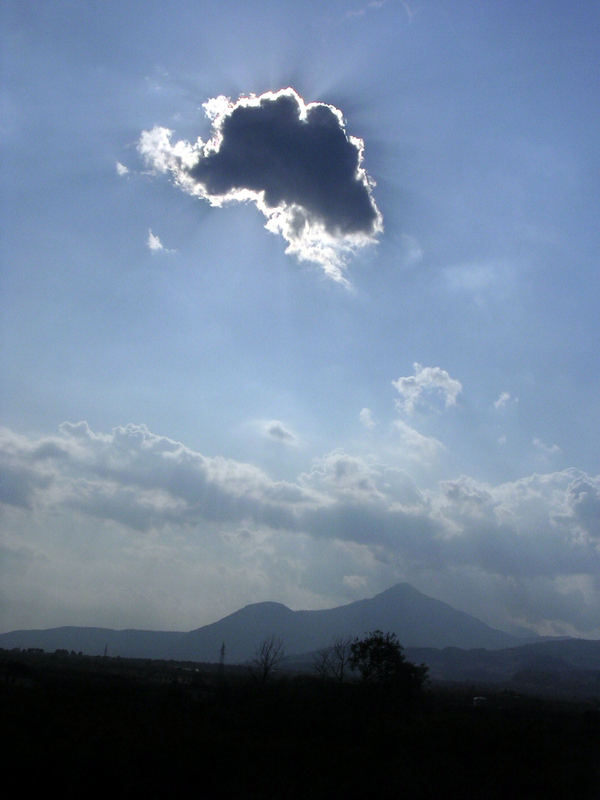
[350,630,427,692]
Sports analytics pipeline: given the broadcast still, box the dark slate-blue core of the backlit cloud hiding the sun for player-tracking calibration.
[188,92,377,235]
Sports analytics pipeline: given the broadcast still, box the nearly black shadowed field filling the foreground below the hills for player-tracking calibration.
[0,651,600,798]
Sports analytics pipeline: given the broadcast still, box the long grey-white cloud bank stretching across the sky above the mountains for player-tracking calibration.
[0,422,600,635]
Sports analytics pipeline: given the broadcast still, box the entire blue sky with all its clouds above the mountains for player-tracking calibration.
[0,0,600,638]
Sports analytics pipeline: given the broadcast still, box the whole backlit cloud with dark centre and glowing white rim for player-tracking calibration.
[138,88,382,282]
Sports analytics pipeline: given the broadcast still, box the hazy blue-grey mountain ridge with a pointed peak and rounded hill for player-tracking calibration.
[0,583,523,663]
